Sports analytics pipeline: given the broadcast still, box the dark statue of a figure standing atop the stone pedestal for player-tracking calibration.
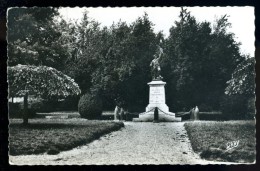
[150,46,163,80]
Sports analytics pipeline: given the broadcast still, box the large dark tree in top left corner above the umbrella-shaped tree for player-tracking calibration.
[7,7,68,70]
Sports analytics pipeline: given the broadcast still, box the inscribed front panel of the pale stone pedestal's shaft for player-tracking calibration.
[149,86,165,103]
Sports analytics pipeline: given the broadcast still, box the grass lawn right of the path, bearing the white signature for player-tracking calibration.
[185,121,256,163]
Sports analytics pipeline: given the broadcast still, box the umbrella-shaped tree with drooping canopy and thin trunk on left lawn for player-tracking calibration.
[8,65,81,124]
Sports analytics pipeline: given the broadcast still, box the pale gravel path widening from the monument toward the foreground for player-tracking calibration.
[9,122,232,165]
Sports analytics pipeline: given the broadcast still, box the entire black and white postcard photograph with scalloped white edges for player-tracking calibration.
[6,6,256,165]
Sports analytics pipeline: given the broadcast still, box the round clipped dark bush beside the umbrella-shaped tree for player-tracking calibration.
[78,93,102,119]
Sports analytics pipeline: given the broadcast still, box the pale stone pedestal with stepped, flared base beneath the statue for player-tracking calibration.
[133,80,181,122]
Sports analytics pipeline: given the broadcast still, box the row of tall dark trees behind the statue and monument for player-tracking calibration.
[8,8,253,115]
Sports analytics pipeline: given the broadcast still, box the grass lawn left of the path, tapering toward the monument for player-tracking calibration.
[9,118,124,155]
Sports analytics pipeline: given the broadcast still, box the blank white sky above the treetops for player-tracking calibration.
[60,7,255,56]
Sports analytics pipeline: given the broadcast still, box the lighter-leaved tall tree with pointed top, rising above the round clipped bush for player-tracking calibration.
[64,11,107,93]
